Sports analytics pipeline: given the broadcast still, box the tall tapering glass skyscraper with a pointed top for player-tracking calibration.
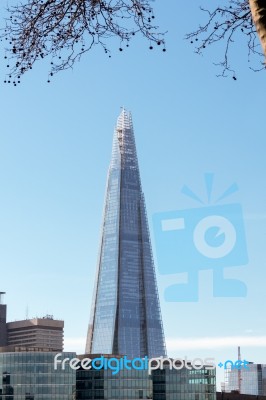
[86,109,166,358]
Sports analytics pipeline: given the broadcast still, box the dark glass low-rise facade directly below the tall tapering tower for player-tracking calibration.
[76,360,216,400]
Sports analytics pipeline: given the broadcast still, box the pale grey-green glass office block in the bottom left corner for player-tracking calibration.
[0,352,76,400]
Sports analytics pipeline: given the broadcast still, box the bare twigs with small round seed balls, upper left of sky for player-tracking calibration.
[1,0,165,85]
